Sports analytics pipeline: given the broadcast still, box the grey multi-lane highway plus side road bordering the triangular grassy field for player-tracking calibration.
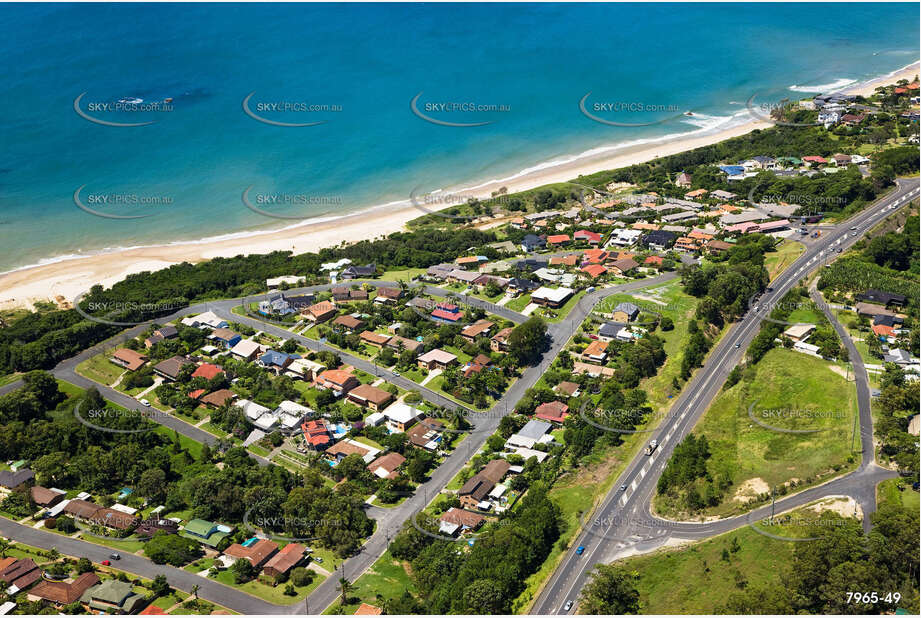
[531,179,918,614]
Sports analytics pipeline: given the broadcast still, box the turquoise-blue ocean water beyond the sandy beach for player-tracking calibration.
[0,4,921,271]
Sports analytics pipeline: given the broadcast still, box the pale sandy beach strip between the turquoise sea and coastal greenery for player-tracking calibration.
[0,62,919,309]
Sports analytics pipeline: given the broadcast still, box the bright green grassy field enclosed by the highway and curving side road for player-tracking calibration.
[656,348,858,516]
